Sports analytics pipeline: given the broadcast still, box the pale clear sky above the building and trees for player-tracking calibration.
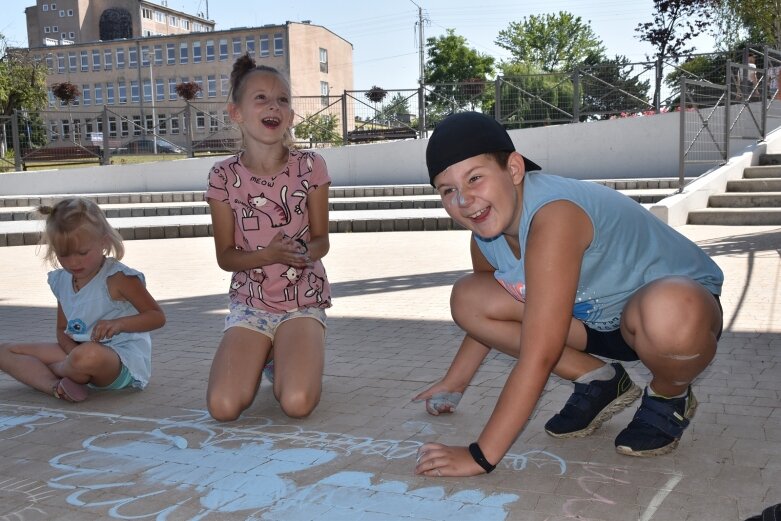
[0,0,713,90]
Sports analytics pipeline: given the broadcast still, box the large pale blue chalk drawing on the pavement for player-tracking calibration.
[38,411,566,521]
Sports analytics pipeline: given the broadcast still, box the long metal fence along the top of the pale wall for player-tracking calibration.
[0,49,781,170]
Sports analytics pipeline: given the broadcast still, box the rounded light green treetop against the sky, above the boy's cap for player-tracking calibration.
[495,11,604,72]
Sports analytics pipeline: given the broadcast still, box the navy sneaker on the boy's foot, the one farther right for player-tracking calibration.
[616,387,697,456]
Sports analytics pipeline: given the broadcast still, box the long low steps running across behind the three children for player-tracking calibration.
[0,178,677,246]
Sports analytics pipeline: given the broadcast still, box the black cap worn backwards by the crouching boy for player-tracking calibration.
[426,112,541,186]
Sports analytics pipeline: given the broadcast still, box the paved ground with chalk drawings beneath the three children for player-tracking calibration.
[0,226,781,521]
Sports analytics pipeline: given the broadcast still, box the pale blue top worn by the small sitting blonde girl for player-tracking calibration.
[48,257,152,389]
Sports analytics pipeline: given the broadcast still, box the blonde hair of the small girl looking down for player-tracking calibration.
[38,197,125,266]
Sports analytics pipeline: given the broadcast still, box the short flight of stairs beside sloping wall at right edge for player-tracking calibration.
[688,150,781,226]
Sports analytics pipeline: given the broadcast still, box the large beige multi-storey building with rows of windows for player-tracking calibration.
[19,0,353,145]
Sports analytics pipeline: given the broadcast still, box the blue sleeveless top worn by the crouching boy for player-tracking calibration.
[475,172,724,331]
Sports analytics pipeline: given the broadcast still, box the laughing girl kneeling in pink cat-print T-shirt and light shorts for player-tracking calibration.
[206,55,331,421]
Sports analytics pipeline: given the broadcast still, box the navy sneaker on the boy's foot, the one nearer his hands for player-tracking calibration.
[545,362,641,438]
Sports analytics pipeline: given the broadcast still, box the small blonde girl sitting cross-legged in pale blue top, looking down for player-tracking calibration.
[0,197,165,402]
